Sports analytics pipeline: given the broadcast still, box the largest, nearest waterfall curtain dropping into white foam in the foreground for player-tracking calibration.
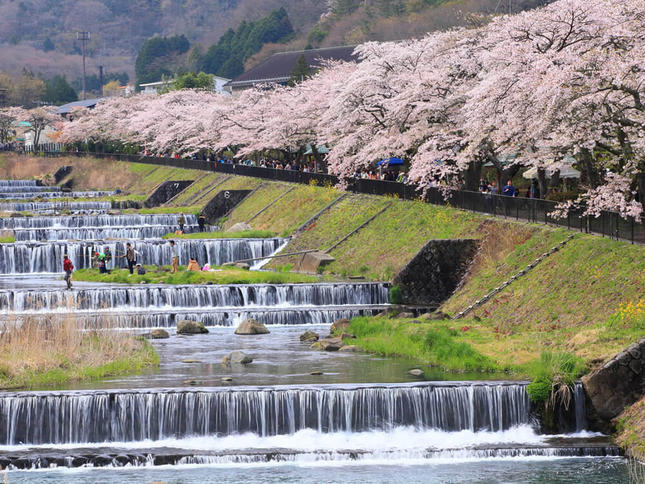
[0,383,532,445]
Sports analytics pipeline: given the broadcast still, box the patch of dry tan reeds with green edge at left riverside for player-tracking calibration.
[0,316,159,389]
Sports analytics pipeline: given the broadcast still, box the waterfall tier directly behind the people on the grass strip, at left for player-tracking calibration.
[0,238,285,274]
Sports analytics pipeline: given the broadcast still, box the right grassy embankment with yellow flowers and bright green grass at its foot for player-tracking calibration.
[340,229,645,377]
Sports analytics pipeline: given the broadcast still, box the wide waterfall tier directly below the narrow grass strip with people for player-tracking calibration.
[0,282,389,313]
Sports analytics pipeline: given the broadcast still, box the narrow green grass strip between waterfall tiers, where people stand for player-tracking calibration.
[74,266,322,285]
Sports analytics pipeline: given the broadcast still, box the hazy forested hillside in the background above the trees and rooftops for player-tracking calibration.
[0,0,549,81]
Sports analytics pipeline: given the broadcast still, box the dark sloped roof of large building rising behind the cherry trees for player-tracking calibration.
[227,45,357,88]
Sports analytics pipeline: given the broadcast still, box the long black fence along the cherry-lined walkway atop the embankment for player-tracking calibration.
[15,151,645,244]
